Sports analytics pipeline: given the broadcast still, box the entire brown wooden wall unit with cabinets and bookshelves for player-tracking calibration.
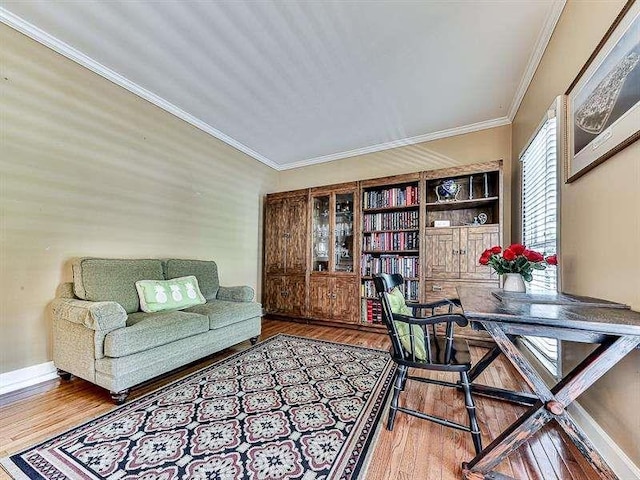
[263,161,503,338]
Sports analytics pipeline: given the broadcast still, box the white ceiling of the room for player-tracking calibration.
[0,0,564,170]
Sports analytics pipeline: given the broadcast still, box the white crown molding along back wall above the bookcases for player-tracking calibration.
[279,117,511,170]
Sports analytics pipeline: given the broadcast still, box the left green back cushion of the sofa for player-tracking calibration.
[72,258,164,313]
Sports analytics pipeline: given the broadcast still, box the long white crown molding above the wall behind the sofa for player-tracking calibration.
[0,7,281,170]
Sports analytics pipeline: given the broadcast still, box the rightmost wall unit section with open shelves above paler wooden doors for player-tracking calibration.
[424,162,503,342]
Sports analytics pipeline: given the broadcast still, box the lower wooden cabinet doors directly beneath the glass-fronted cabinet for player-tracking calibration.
[308,274,359,323]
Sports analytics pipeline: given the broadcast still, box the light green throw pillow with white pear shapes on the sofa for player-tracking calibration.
[136,275,206,313]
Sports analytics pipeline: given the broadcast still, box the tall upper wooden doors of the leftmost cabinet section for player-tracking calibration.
[264,193,309,274]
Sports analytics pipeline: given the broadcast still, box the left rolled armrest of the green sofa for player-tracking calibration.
[51,298,127,332]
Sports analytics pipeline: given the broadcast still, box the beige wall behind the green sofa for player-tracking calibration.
[0,24,277,373]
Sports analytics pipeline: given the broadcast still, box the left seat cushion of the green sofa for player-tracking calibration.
[104,311,209,357]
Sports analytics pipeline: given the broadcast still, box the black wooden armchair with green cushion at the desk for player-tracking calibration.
[373,273,482,454]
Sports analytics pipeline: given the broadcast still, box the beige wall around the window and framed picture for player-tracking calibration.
[513,0,640,465]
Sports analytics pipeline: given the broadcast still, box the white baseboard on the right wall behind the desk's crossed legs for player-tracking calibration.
[567,402,640,480]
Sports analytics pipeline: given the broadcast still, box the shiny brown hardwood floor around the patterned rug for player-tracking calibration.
[0,320,598,480]
